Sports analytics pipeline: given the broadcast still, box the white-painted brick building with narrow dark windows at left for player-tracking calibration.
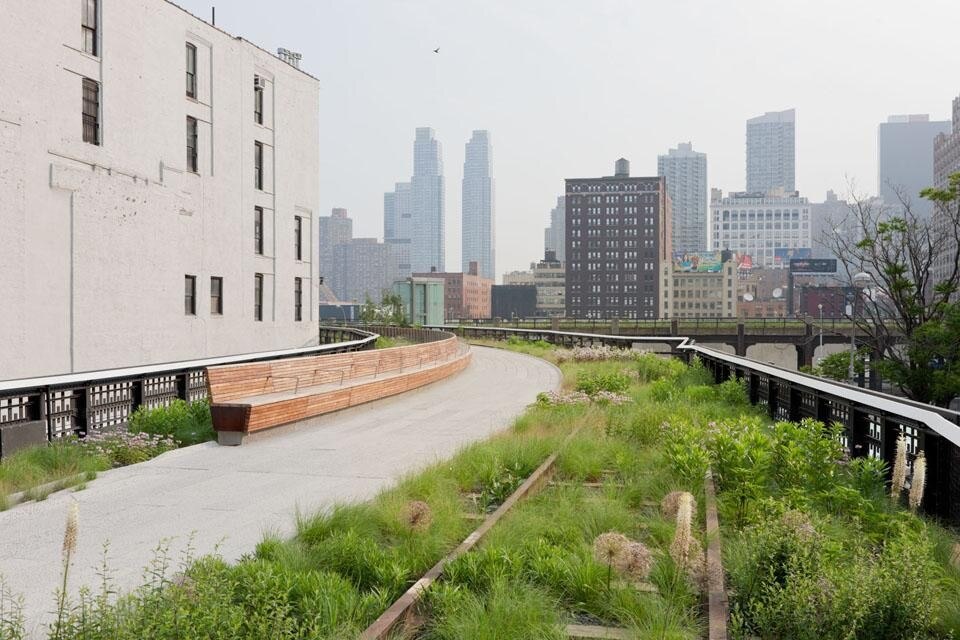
[0,0,319,379]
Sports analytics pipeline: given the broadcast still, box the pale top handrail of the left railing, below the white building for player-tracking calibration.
[0,326,380,392]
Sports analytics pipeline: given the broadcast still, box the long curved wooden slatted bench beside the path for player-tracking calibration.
[207,336,470,445]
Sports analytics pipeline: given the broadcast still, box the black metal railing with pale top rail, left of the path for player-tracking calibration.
[0,327,379,457]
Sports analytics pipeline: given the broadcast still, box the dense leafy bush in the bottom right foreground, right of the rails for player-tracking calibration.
[726,511,938,640]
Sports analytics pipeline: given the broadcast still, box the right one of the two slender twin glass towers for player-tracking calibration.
[464,130,496,280]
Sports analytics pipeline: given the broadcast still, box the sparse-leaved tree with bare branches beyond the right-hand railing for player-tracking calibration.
[826,173,960,402]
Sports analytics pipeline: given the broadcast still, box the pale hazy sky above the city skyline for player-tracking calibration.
[178,0,960,277]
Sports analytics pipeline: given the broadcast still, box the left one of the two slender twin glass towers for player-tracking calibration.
[409,127,445,273]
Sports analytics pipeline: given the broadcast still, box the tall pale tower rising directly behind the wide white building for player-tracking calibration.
[747,109,797,194]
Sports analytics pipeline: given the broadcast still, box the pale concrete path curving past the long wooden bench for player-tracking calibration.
[0,347,560,632]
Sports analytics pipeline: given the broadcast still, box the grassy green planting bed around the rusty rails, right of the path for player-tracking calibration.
[0,342,960,640]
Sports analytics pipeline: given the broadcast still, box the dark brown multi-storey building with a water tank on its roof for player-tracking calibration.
[565,158,672,318]
